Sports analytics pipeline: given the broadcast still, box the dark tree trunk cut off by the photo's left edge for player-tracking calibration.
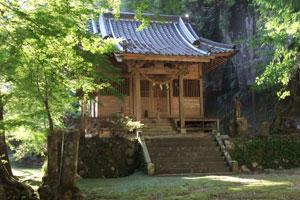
[0,94,12,176]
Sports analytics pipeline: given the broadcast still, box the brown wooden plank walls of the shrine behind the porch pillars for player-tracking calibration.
[98,64,203,122]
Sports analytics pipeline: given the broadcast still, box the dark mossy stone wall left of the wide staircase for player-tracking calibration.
[78,136,140,178]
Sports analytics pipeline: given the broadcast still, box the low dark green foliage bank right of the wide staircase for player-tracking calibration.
[232,136,300,169]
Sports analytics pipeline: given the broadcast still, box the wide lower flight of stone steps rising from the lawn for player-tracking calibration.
[144,133,230,174]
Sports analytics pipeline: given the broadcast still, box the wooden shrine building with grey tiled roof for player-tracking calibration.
[92,13,237,133]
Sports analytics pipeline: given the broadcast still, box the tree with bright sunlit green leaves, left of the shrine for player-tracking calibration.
[0,0,120,196]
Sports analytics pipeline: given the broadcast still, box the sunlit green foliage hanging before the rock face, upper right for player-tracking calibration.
[255,0,300,98]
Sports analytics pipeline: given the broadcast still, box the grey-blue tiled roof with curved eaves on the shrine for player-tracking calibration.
[92,13,235,57]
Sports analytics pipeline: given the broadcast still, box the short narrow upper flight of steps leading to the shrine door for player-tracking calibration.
[142,119,177,136]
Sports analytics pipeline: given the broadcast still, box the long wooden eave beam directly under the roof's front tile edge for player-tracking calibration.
[122,53,215,63]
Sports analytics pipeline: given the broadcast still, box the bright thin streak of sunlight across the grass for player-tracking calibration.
[183,176,290,187]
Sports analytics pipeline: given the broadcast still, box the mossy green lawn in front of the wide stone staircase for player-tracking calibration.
[77,169,300,200]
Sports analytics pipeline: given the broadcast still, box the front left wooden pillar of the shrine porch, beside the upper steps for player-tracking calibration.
[133,72,142,121]
